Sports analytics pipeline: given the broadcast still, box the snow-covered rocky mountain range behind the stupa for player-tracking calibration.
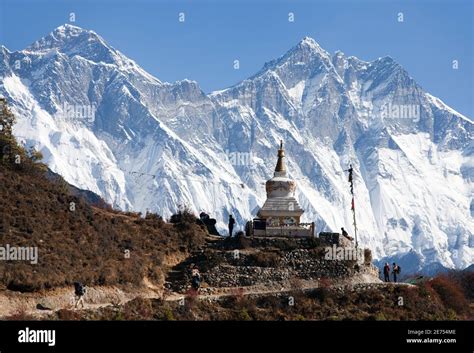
[0,25,474,268]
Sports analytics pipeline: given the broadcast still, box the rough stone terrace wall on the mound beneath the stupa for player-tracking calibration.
[168,237,378,292]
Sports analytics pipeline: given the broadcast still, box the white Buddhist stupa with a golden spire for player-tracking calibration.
[257,142,304,226]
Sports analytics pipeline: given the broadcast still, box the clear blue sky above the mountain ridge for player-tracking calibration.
[0,0,474,118]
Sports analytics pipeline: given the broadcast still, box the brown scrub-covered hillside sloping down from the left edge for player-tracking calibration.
[0,99,206,292]
